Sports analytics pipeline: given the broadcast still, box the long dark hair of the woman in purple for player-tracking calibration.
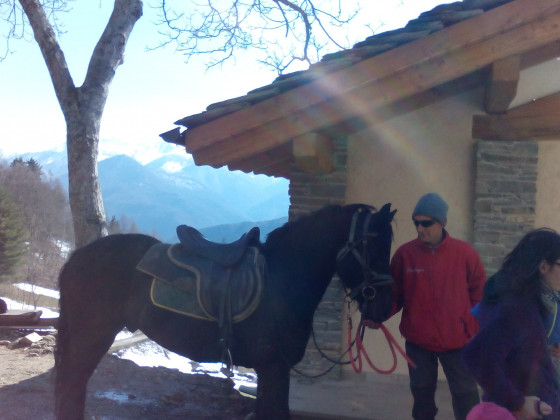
[484,228,560,302]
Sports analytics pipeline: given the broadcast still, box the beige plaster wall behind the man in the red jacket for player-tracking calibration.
[343,89,482,375]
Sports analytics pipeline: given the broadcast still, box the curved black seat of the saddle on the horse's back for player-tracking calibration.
[177,225,261,267]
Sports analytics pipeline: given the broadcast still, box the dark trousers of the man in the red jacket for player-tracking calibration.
[405,341,480,420]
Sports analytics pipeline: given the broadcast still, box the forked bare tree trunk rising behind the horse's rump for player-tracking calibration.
[19,0,142,247]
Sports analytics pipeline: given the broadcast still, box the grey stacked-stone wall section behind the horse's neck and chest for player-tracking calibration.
[289,138,347,379]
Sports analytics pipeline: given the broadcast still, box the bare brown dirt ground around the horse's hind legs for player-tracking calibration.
[0,330,255,420]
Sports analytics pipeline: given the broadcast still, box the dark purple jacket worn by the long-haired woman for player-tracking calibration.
[463,296,560,420]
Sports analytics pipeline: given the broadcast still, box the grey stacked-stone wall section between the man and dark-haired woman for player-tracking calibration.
[474,141,539,276]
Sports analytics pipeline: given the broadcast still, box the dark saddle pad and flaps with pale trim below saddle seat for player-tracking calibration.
[136,244,264,322]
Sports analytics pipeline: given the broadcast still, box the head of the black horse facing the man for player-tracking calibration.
[337,203,397,323]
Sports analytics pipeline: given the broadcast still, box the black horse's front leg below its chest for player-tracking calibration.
[255,361,290,420]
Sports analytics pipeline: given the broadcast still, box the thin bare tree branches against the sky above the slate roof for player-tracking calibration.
[152,0,364,73]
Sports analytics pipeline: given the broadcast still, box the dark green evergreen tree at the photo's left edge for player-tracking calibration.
[0,186,26,281]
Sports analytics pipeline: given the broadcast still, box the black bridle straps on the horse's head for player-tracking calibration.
[336,209,393,303]
